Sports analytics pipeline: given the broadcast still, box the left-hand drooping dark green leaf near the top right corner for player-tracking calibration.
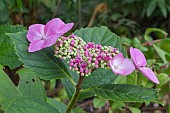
[146,0,157,17]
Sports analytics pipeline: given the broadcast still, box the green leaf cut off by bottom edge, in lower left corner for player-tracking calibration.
[5,97,59,113]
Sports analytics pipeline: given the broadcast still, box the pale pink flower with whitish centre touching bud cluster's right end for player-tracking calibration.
[109,53,135,76]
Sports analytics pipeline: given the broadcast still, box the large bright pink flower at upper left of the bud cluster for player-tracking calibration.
[27,18,74,52]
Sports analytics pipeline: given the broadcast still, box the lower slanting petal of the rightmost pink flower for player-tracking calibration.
[139,67,159,84]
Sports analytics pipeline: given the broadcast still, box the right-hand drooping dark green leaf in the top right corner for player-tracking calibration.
[157,0,167,18]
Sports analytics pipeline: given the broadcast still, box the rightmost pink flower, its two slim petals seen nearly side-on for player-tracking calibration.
[130,47,159,84]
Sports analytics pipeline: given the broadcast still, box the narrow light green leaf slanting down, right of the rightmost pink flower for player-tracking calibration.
[153,44,168,63]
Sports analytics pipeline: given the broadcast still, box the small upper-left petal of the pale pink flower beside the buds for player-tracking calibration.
[110,53,124,66]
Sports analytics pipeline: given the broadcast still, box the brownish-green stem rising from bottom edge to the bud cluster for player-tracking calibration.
[66,75,84,113]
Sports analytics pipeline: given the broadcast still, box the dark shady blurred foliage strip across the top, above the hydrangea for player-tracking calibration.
[0,0,170,37]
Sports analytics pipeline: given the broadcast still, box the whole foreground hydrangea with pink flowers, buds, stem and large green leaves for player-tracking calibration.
[0,18,160,113]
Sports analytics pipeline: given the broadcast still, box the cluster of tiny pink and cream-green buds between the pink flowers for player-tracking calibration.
[55,35,119,76]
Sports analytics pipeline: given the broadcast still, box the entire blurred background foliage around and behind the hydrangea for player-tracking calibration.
[0,0,170,113]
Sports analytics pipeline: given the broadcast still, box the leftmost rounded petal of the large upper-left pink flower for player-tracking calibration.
[26,24,45,42]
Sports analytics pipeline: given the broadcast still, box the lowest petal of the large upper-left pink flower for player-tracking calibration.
[28,40,44,52]
